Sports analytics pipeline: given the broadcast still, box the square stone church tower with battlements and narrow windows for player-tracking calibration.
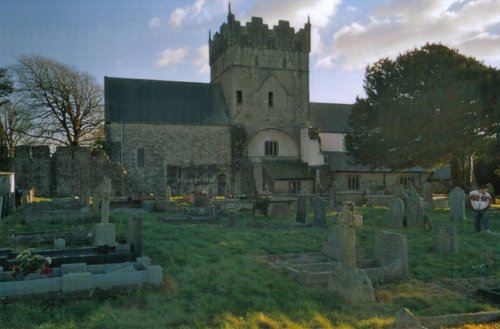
[209,7,311,191]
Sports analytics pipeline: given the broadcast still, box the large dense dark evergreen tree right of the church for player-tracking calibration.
[345,44,498,188]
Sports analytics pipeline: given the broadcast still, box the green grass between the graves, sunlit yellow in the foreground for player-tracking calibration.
[0,201,500,329]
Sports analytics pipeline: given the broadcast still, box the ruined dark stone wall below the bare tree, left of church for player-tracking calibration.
[10,146,128,197]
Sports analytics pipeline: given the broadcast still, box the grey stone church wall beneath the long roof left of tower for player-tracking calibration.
[106,123,232,196]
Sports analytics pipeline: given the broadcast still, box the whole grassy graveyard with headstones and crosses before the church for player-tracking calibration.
[0,190,500,329]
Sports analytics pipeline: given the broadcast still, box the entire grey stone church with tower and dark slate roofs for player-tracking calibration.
[104,9,428,196]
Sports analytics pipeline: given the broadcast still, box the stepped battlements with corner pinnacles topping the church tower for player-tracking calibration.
[209,11,311,64]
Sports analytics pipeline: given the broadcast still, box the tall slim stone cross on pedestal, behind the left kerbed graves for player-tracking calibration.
[94,177,116,246]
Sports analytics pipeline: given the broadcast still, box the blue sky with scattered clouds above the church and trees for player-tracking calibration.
[0,0,500,103]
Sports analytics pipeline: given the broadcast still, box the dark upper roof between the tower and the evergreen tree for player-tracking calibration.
[309,103,352,133]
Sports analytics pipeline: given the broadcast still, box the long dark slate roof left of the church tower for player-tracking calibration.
[104,77,230,125]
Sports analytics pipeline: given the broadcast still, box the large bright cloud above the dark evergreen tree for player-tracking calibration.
[330,0,500,69]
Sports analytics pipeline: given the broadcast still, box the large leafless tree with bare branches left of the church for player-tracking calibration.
[14,56,104,146]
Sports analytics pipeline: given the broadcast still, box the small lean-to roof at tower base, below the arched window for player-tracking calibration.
[263,160,316,179]
